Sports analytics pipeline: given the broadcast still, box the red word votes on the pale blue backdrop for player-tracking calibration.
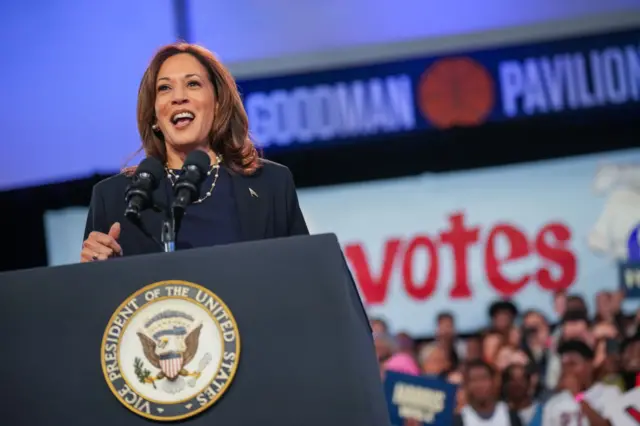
[345,213,577,304]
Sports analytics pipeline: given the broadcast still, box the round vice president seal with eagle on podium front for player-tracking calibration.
[100,281,240,421]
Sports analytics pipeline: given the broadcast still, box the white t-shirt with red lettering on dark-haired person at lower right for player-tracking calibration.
[542,383,621,426]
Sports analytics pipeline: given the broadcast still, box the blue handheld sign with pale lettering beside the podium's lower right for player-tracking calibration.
[384,371,457,426]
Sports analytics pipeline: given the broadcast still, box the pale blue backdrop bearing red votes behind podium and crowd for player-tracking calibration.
[46,150,640,335]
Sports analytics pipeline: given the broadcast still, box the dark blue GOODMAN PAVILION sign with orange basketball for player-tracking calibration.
[238,30,640,148]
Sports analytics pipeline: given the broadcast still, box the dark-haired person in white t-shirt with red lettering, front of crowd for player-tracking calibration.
[542,340,621,426]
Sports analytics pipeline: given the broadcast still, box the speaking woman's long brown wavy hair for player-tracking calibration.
[131,42,261,175]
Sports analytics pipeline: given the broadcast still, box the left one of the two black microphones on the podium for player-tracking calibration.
[124,157,164,221]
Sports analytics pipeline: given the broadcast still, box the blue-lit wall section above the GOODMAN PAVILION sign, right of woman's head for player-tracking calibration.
[195,0,640,74]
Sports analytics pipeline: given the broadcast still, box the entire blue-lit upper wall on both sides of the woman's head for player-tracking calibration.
[0,0,640,190]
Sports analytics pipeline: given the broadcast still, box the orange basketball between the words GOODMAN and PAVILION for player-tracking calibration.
[418,57,495,129]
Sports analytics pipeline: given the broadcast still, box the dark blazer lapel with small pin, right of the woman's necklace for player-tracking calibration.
[229,171,269,241]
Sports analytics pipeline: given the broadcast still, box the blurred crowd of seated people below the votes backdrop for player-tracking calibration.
[370,292,640,426]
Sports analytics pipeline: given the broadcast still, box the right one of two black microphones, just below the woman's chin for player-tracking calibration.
[172,150,211,214]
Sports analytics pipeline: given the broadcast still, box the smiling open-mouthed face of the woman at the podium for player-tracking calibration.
[155,53,216,151]
